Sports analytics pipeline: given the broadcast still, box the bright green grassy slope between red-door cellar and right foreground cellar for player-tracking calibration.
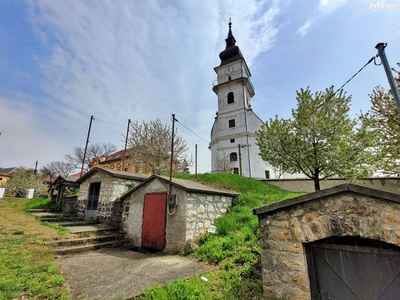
[134,174,301,300]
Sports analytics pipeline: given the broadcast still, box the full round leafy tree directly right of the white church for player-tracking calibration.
[256,86,373,190]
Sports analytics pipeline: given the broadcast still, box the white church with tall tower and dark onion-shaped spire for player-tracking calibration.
[210,21,278,179]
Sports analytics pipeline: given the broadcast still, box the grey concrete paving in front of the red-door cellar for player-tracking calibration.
[59,249,214,300]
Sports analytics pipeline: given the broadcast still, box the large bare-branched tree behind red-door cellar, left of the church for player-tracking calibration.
[128,119,193,175]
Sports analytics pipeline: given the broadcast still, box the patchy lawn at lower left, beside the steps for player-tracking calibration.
[0,198,70,300]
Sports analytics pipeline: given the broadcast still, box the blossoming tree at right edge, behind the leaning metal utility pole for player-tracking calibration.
[361,63,400,175]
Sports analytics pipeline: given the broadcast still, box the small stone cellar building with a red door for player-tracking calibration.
[121,175,238,252]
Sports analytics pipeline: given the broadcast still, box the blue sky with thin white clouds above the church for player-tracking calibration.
[0,0,400,172]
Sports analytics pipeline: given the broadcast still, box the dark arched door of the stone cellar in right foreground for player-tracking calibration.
[306,238,400,300]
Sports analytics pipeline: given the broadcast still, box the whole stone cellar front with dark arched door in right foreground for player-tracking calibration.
[254,184,400,300]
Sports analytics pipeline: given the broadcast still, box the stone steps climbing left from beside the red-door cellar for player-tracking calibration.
[30,209,130,255]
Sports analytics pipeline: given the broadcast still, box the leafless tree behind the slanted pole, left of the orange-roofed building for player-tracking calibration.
[65,143,117,171]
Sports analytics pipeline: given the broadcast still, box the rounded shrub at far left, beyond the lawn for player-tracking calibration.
[5,167,47,197]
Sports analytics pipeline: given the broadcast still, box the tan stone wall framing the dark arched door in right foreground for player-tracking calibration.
[259,192,400,300]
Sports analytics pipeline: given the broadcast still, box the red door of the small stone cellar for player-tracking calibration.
[142,194,167,250]
